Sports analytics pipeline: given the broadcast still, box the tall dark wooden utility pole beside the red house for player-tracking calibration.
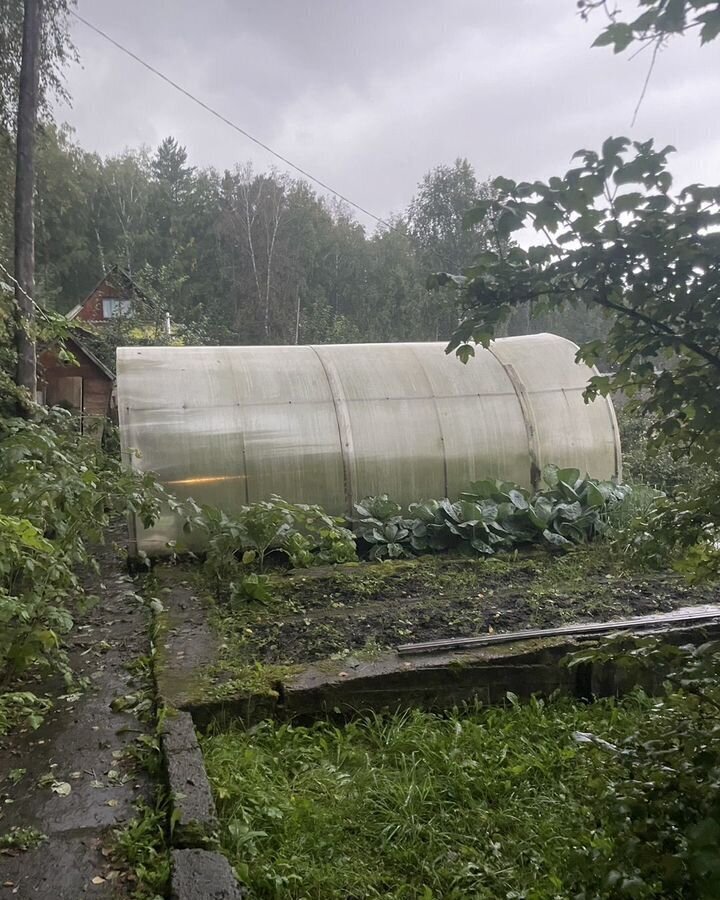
[15,0,43,400]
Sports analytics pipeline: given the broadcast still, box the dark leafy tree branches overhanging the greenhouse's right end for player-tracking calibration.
[447,140,720,465]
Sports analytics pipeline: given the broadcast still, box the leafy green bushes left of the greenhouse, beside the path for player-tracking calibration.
[0,409,168,685]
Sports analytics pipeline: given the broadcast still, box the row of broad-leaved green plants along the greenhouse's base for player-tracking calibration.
[198,465,630,602]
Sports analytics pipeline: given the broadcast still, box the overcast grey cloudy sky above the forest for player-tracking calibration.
[58,0,720,230]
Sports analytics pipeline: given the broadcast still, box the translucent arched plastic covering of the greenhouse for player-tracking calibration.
[118,334,620,553]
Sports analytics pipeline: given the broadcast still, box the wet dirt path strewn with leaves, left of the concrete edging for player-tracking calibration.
[0,536,153,900]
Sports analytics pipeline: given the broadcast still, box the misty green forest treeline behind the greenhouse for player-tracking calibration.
[0,124,603,344]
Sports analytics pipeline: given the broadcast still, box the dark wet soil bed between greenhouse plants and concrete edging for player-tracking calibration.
[166,550,720,666]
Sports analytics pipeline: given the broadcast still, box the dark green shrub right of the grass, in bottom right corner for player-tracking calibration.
[573,636,720,900]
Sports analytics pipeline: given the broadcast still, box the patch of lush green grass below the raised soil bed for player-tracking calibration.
[203,697,647,900]
